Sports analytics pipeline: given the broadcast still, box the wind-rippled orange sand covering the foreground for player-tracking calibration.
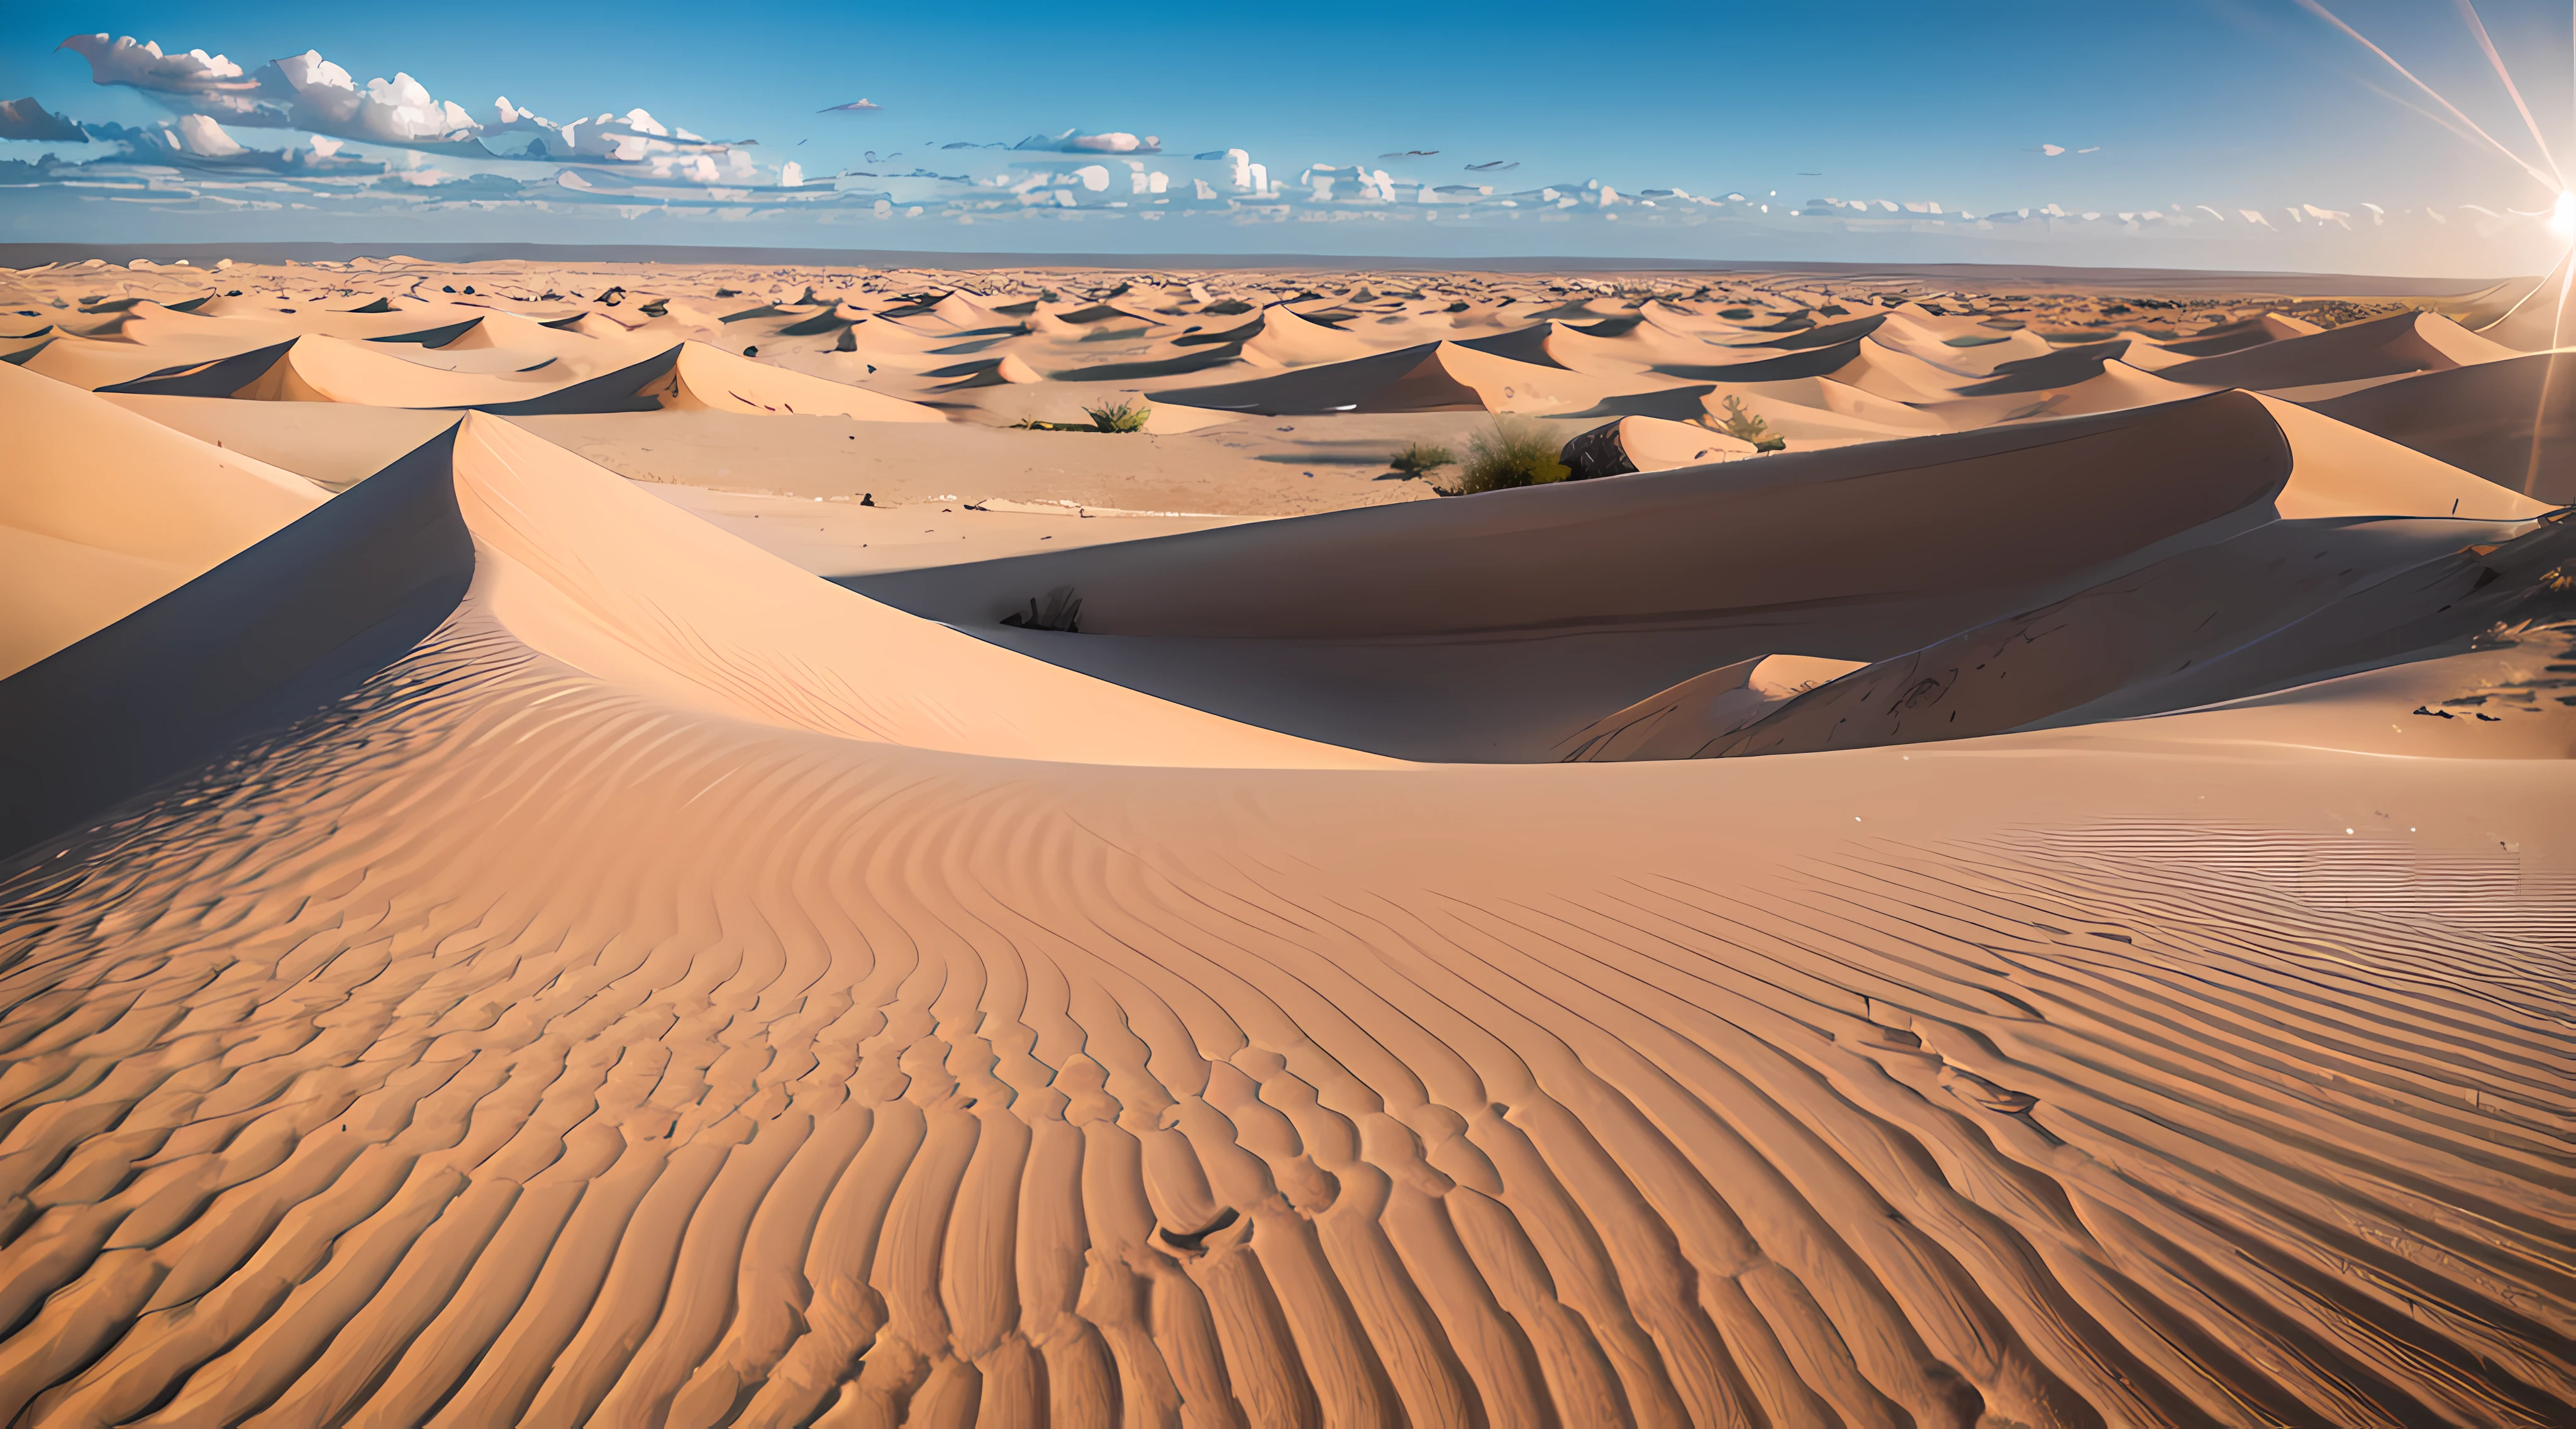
[0,615,2576,1429]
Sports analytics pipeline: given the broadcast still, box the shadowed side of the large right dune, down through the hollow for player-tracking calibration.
[853,394,2318,760]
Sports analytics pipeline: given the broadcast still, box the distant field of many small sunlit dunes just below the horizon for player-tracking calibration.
[28,256,2501,448]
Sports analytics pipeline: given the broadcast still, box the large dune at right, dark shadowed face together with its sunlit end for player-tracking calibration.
[850,394,2576,762]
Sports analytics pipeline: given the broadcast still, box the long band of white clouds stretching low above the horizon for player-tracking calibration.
[0,33,2550,268]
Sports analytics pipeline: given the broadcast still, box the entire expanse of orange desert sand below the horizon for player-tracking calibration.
[0,260,2576,1429]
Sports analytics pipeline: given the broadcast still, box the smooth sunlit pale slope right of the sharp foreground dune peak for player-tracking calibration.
[453,412,1380,767]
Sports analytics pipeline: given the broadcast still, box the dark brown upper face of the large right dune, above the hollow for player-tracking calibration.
[860,394,2297,636]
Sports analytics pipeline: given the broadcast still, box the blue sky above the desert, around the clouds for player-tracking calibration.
[0,0,2576,273]
